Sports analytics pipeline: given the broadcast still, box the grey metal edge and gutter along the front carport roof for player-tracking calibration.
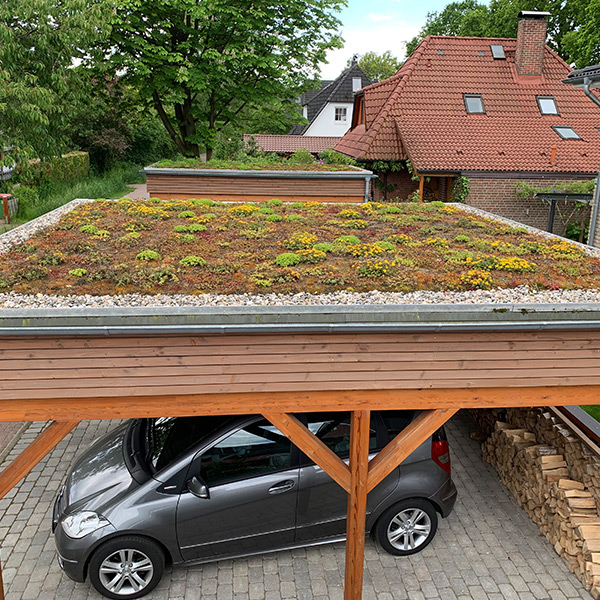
[0,303,600,336]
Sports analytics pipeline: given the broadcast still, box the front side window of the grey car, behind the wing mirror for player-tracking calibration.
[200,421,291,486]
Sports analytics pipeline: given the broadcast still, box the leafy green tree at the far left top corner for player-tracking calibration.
[0,0,106,157]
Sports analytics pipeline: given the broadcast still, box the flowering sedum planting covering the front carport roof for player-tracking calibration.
[0,199,600,295]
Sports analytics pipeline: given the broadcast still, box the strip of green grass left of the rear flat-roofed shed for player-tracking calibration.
[9,165,144,228]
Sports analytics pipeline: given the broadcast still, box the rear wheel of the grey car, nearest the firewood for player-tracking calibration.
[375,498,438,556]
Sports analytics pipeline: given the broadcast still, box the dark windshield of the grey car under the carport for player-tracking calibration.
[142,416,231,473]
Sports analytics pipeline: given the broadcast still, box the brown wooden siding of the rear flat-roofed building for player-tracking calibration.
[146,173,365,202]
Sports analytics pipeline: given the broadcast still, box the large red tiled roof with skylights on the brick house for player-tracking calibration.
[335,36,600,174]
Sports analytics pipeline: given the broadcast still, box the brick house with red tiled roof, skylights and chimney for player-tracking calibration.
[335,11,600,233]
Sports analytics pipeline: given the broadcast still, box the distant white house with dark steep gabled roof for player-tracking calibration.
[290,58,371,137]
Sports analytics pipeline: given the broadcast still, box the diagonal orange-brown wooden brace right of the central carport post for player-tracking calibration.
[367,408,456,492]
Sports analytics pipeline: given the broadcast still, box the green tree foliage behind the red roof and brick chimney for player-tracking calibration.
[406,0,600,66]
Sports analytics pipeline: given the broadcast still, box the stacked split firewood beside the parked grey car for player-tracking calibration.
[471,408,600,598]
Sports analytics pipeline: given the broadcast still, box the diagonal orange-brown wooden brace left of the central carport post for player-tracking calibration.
[263,413,350,492]
